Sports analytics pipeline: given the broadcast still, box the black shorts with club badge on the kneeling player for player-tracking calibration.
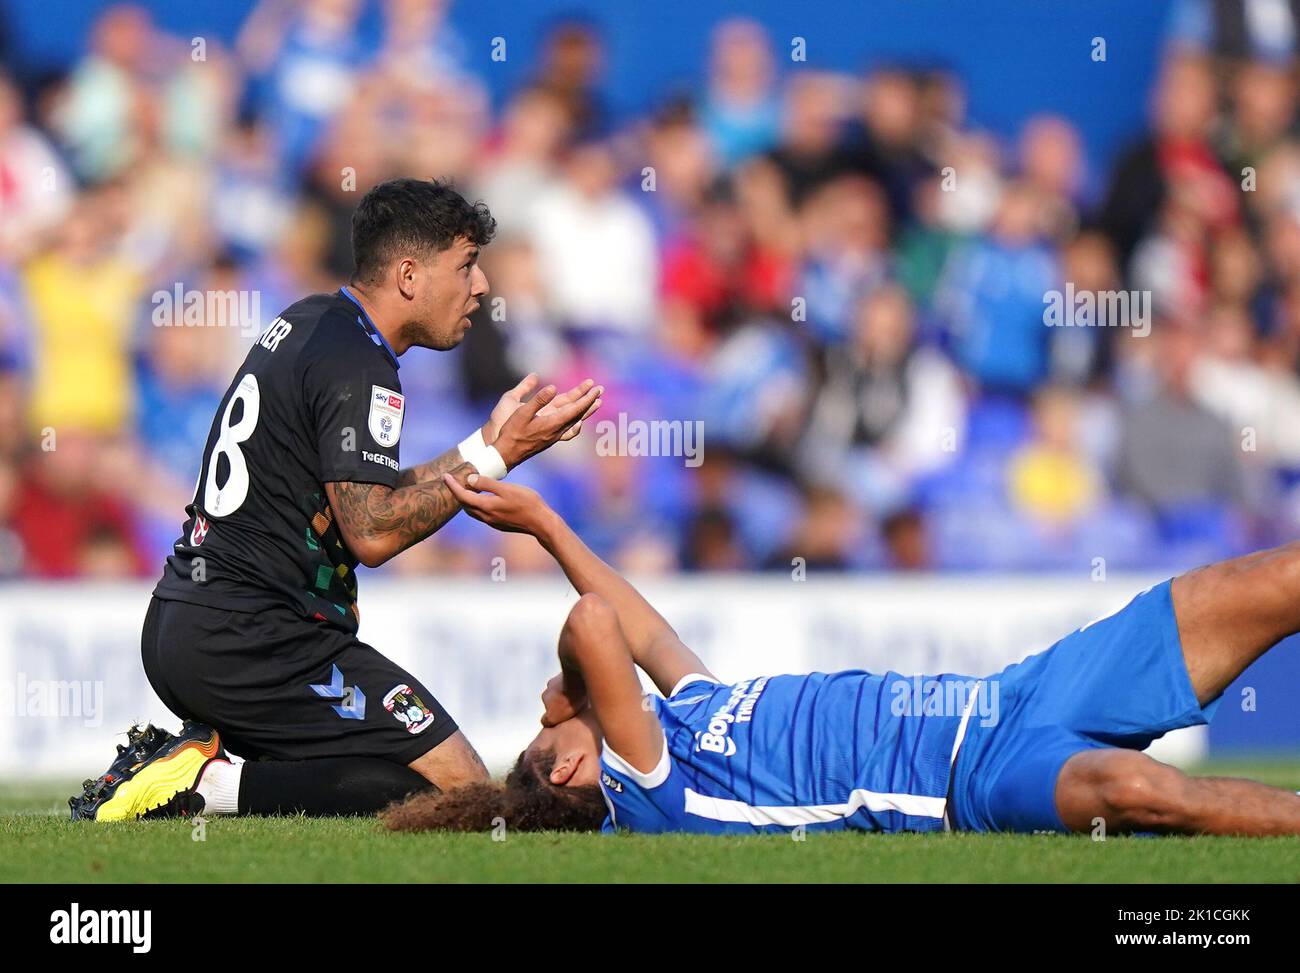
[140,598,456,764]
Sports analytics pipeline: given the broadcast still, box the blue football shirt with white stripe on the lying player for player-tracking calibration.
[601,671,980,834]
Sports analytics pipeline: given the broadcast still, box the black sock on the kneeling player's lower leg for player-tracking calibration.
[239,757,433,817]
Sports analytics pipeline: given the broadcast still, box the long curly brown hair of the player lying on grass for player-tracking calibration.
[380,751,605,831]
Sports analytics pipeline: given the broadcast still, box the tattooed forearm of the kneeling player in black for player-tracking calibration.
[325,460,475,567]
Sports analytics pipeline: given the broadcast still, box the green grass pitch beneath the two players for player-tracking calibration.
[0,761,1300,883]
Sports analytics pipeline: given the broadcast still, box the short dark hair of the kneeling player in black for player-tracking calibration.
[352,180,497,284]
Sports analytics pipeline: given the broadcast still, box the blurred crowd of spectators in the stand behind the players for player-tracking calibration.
[0,0,1300,578]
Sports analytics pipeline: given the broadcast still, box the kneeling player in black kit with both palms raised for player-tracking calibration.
[70,180,602,821]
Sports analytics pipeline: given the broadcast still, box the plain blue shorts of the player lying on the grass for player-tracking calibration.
[948,581,1219,831]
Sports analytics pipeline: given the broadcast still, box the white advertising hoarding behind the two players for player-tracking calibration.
[0,576,1206,780]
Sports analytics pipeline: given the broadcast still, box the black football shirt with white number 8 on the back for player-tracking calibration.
[153,287,406,632]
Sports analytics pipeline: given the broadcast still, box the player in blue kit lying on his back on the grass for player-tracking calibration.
[385,476,1300,835]
